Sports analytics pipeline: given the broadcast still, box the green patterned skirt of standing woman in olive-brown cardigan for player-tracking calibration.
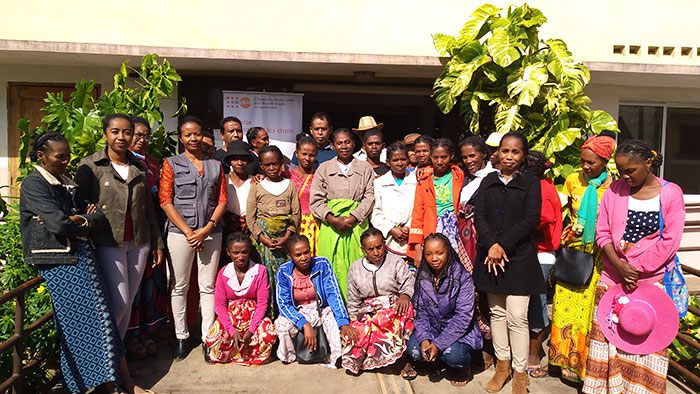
[253,215,292,317]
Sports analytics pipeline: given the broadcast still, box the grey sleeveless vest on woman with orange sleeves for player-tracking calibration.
[165,153,221,234]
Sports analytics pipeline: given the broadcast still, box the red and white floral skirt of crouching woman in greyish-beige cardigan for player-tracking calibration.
[343,295,414,373]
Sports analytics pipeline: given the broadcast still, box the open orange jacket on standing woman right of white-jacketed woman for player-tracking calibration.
[408,165,464,256]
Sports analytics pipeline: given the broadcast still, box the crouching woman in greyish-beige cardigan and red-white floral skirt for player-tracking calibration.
[343,229,416,379]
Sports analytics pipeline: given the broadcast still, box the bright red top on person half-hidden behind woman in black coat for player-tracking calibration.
[535,178,562,252]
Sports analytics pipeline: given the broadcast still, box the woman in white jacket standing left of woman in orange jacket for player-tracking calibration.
[371,142,417,264]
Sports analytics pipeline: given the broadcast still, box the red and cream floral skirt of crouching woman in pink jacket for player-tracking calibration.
[206,300,277,367]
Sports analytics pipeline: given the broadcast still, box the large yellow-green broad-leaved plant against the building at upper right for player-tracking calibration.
[433,4,619,183]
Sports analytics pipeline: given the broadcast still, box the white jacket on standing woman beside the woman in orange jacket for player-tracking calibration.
[370,170,418,254]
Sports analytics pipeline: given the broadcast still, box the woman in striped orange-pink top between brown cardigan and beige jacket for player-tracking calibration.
[289,134,319,255]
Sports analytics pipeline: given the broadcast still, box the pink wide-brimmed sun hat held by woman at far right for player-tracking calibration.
[598,283,678,354]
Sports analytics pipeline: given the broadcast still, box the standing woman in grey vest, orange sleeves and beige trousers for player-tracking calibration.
[160,116,228,361]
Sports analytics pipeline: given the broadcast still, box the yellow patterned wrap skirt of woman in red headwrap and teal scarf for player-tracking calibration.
[549,228,603,383]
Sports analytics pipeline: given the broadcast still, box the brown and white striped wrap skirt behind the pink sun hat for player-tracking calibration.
[583,282,668,394]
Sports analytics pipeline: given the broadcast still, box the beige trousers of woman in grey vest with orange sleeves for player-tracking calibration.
[168,233,221,342]
